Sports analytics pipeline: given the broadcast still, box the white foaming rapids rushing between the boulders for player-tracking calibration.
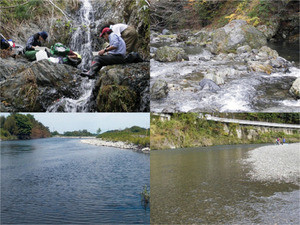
[150,43,300,112]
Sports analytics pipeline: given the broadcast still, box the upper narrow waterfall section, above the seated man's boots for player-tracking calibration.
[70,0,94,69]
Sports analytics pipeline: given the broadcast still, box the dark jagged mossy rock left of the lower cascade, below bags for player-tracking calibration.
[0,57,82,112]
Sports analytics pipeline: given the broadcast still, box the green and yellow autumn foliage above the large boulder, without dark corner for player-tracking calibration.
[151,0,292,30]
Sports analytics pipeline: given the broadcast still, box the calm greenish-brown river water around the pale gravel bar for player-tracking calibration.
[151,145,300,224]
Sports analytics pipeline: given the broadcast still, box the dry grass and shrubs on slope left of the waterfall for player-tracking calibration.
[0,0,79,47]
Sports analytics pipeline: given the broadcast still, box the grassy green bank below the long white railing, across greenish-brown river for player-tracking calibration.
[151,113,300,149]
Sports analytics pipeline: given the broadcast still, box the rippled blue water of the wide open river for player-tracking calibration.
[1,138,150,224]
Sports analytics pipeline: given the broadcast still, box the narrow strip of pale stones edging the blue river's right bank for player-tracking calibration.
[80,138,150,153]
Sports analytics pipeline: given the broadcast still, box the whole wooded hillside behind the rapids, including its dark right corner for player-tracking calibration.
[150,0,299,42]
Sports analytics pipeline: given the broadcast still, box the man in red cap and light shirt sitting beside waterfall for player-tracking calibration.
[81,27,126,79]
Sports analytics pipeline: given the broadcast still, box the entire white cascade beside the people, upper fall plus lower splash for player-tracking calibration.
[47,0,95,112]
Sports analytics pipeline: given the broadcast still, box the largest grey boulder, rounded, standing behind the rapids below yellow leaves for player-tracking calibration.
[211,20,267,53]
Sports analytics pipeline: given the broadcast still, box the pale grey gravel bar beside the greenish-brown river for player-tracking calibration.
[243,143,300,185]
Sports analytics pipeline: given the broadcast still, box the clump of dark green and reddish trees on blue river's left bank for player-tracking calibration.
[0,114,51,140]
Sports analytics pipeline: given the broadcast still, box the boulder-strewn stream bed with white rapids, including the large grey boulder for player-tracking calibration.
[150,20,300,112]
